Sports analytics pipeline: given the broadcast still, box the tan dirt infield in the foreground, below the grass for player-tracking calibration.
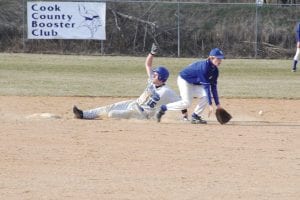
[0,96,300,200]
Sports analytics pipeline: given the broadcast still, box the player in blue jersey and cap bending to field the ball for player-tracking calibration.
[156,48,224,124]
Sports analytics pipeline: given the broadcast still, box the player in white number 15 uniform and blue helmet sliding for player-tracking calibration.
[73,44,180,119]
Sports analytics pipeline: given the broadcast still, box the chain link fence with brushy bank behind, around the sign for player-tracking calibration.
[0,0,300,58]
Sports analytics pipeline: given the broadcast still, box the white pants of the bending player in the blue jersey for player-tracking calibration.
[166,76,208,115]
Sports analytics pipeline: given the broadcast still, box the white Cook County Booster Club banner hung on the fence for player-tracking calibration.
[27,1,106,40]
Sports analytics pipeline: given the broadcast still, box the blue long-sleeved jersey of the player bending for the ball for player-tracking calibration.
[179,59,220,105]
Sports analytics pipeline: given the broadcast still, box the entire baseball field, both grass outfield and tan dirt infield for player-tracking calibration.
[0,54,300,200]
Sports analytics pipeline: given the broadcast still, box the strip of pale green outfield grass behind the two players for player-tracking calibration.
[0,53,300,99]
